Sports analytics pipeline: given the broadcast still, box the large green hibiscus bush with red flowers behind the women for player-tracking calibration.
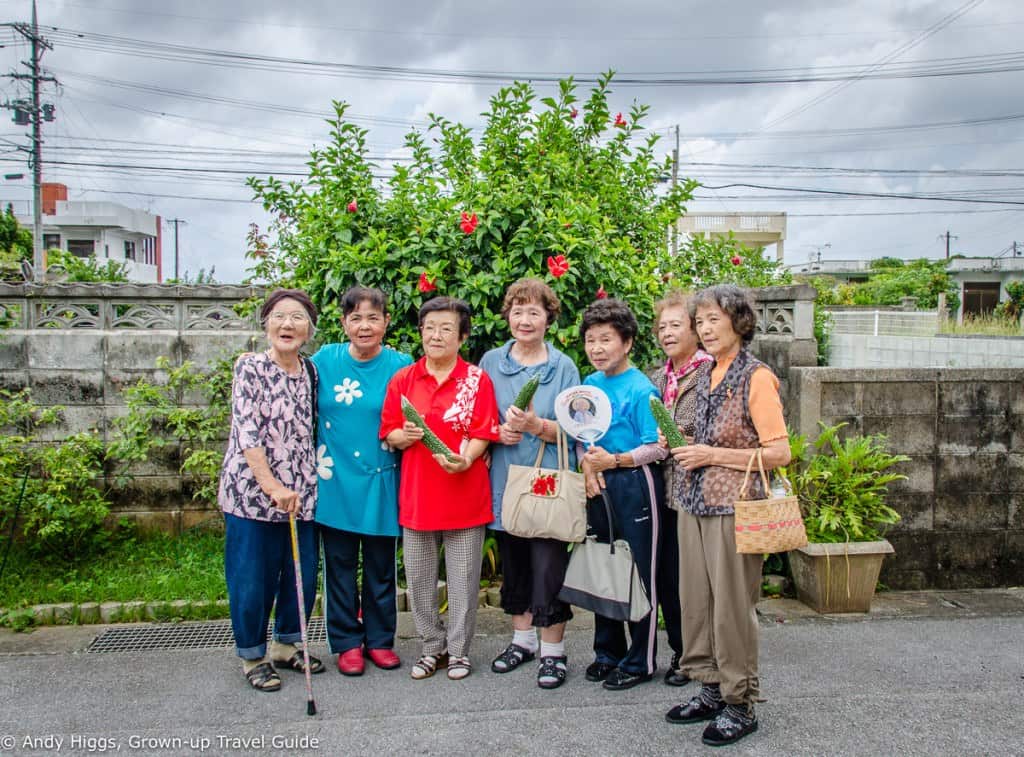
[249,72,777,365]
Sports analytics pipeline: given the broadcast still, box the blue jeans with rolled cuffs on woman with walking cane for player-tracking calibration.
[224,513,319,660]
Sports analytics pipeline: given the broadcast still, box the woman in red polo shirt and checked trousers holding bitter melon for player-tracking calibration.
[380,297,499,680]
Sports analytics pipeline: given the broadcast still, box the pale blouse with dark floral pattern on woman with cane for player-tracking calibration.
[217,352,316,521]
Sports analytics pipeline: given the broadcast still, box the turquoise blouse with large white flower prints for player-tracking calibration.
[311,343,413,536]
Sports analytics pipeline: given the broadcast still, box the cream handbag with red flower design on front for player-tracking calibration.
[502,429,587,542]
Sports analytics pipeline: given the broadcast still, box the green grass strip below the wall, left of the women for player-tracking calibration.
[0,530,227,608]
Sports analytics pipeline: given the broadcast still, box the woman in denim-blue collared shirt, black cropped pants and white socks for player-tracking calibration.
[480,279,580,688]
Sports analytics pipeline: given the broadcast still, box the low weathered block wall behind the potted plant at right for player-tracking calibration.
[790,368,1024,589]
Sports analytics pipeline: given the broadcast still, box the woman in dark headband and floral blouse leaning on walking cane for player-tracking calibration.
[217,289,324,691]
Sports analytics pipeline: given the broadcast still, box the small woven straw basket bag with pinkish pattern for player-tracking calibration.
[734,450,807,554]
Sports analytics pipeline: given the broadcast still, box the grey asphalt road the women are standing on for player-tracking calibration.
[0,609,1024,756]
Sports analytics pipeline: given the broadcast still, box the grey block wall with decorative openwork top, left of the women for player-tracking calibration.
[0,284,261,531]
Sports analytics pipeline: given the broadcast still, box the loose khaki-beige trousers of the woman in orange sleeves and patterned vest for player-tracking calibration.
[679,511,764,705]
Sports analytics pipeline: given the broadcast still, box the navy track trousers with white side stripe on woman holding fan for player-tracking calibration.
[587,465,665,674]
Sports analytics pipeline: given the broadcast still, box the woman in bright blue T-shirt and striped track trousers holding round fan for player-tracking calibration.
[580,299,666,690]
